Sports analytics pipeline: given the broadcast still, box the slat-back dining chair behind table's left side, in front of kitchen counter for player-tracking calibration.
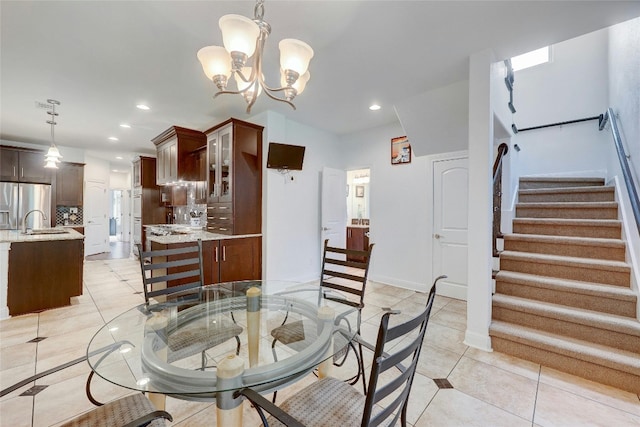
[137,240,242,369]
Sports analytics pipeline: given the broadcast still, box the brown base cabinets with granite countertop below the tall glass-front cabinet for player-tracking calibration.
[145,225,262,286]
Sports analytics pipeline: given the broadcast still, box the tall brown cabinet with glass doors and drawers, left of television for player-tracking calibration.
[205,119,263,234]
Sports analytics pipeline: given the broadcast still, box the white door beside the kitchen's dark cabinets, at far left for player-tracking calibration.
[84,181,109,256]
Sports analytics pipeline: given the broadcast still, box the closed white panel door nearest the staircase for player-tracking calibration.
[432,158,469,300]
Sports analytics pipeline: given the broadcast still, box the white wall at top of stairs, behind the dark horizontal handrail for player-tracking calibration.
[508,30,611,190]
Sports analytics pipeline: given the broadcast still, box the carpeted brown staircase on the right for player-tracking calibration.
[490,178,640,394]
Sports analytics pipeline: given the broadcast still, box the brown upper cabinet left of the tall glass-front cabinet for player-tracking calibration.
[151,126,206,185]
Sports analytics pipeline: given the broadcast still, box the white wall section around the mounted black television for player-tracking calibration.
[248,111,345,282]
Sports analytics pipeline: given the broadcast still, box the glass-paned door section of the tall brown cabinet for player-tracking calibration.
[207,125,233,203]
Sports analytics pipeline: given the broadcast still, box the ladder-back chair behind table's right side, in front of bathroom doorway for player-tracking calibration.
[271,239,373,394]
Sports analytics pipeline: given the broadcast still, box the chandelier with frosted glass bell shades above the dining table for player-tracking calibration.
[198,0,313,113]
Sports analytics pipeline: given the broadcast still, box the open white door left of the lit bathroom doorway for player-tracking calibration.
[321,167,347,248]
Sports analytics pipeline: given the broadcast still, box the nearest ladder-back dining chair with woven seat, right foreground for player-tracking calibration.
[236,276,446,427]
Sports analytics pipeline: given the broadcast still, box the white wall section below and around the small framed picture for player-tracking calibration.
[341,123,430,291]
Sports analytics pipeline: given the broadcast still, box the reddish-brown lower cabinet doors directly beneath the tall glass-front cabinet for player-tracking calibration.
[219,237,262,282]
